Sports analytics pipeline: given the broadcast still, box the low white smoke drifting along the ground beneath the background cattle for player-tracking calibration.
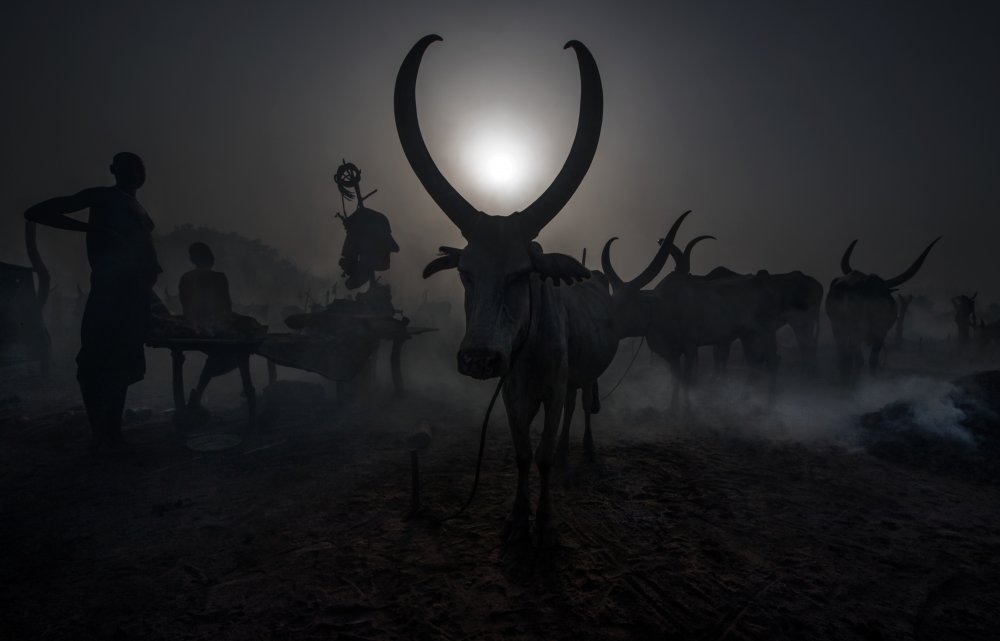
[599,341,989,449]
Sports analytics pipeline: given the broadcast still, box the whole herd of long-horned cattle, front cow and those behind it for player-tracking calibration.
[394,35,988,541]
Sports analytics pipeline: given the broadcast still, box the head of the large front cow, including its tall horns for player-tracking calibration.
[395,35,604,378]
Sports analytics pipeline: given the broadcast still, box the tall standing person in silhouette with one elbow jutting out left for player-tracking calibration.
[24,152,162,454]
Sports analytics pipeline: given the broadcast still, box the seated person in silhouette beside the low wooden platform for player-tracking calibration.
[177,243,239,408]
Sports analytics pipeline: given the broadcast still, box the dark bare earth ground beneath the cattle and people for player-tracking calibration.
[0,338,1000,640]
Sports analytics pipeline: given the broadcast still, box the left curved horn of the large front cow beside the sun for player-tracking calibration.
[393,35,476,236]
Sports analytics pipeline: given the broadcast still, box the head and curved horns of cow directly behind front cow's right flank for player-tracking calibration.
[601,211,710,337]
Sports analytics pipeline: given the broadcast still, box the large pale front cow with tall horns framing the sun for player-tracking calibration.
[395,35,618,544]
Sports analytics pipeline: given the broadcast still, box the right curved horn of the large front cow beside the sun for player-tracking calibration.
[516,40,604,240]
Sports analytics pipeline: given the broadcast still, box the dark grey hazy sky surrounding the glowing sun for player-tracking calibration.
[0,0,1000,297]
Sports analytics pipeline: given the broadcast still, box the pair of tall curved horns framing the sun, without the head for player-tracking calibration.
[394,35,604,240]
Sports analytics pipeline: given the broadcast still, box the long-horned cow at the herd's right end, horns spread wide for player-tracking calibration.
[826,236,941,383]
